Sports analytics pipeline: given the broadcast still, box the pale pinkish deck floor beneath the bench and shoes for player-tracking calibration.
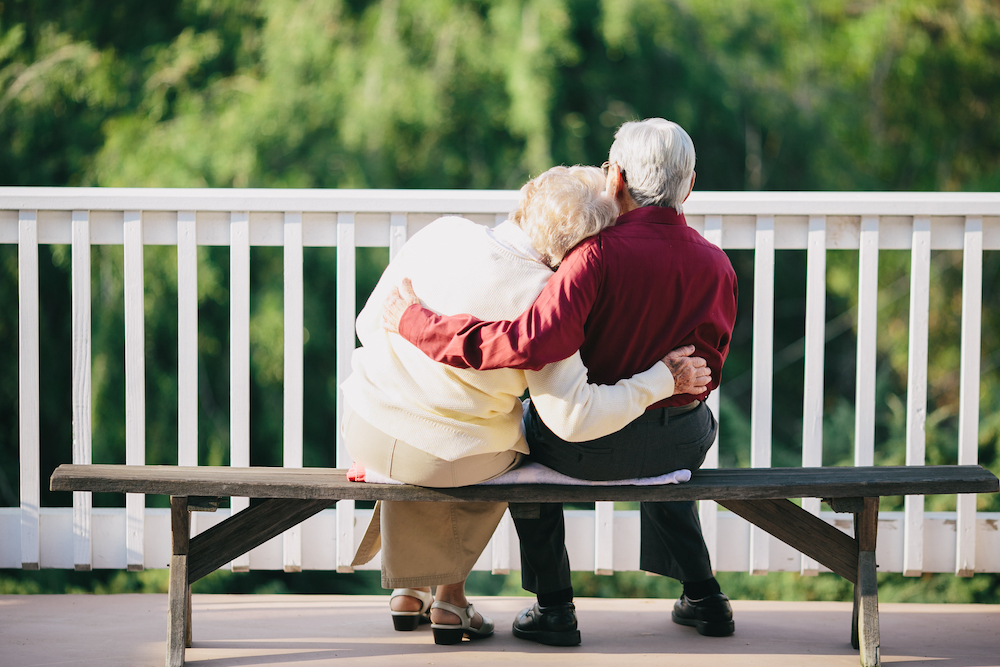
[0,595,1000,667]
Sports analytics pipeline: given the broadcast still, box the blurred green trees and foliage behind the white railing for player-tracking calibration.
[0,0,1000,602]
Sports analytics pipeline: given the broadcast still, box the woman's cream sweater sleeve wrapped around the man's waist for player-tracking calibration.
[525,351,674,442]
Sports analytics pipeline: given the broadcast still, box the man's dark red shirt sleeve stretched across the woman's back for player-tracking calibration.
[399,242,602,370]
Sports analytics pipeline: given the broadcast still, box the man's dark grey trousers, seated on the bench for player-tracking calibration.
[514,403,719,593]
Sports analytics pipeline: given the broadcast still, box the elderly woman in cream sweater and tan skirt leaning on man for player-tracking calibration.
[343,167,708,643]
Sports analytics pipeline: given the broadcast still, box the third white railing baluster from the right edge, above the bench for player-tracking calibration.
[854,216,878,466]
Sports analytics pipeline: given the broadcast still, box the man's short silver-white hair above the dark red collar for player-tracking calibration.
[608,118,695,213]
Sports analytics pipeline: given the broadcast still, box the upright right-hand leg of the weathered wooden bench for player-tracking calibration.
[851,498,881,667]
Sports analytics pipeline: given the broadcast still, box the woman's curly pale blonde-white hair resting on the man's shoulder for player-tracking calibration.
[510,166,618,268]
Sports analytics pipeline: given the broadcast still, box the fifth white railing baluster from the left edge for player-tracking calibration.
[229,211,250,572]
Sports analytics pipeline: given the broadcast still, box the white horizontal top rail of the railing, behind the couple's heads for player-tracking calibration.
[0,187,1000,216]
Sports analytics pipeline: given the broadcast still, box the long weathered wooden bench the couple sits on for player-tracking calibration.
[51,465,998,667]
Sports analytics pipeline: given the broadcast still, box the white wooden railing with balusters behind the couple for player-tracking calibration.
[0,188,1000,576]
